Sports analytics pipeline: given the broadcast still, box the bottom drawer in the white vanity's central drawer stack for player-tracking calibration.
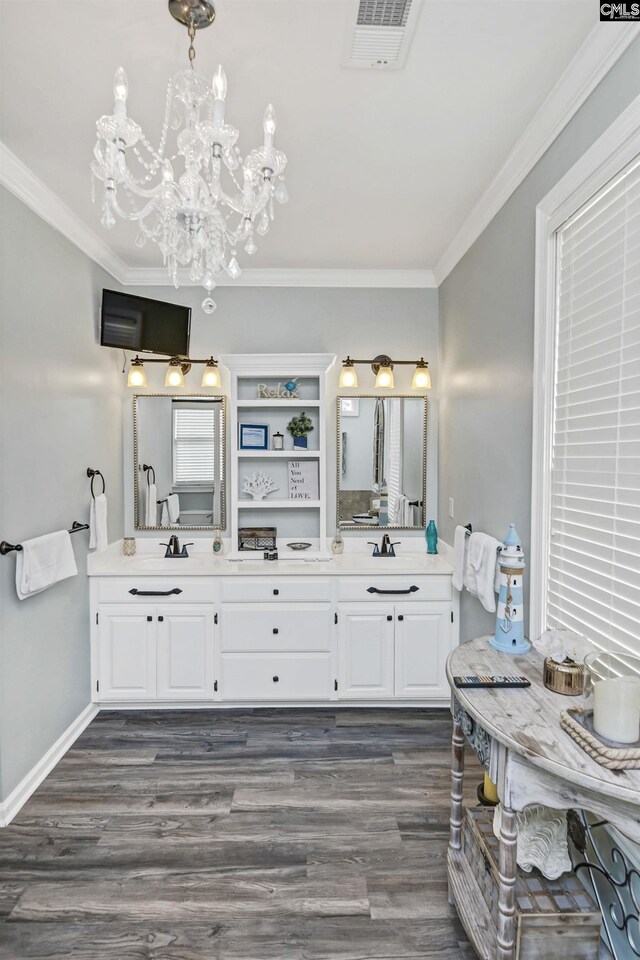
[220,653,333,700]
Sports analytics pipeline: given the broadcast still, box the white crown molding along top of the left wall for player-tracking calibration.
[0,141,127,283]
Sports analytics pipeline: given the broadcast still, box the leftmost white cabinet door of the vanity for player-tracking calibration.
[98,604,156,700]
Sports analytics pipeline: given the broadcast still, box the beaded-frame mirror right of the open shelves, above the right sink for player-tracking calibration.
[336,394,427,530]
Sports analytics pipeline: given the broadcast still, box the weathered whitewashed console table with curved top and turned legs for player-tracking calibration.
[447,637,640,960]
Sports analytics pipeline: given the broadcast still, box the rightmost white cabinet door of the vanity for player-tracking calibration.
[395,603,451,700]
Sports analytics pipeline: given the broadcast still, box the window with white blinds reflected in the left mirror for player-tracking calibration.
[173,405,215,488]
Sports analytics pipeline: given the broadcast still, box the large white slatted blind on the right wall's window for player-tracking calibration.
[547,158,640,654]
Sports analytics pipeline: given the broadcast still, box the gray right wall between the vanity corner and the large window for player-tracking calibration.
[439,40,640,640]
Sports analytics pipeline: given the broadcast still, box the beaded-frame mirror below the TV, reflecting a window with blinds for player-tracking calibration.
[133,393,226,530]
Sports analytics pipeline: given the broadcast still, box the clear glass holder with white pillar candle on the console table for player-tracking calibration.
[584,651,640,743]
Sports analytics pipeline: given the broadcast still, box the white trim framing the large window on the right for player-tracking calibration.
[530,97,640,637]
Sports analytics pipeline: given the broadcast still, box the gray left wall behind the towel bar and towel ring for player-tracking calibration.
[0,189,123,799]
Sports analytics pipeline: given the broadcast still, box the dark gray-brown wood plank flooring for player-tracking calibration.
[0,708,482,960]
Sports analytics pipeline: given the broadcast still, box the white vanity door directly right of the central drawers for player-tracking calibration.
[338,603,393,700]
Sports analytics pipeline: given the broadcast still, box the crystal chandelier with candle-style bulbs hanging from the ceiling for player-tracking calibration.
[91,0,288,313]
